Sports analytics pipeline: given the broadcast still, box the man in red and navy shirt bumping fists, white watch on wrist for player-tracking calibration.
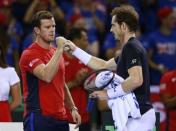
[20,11,81,131]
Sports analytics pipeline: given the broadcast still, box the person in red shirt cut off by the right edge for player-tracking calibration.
[160,70,176,131]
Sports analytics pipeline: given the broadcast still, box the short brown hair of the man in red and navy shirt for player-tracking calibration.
[32,11,54,28]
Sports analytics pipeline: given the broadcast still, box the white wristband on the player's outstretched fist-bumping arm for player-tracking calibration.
[72,47,92,65]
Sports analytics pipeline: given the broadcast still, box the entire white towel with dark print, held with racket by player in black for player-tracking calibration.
[95,71,141,131]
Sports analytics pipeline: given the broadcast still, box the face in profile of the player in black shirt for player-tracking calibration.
[110,16,122,39]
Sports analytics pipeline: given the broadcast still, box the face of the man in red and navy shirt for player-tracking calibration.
[38,18,56,43]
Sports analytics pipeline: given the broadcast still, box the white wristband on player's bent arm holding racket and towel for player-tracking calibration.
[107,84,127,99]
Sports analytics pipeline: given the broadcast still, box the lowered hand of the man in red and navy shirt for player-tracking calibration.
[71,109,81,129]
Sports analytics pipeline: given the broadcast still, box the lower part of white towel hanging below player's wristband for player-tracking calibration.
[108,93,141,131]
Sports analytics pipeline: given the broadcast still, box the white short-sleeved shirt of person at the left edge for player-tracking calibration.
[0,67,20,101]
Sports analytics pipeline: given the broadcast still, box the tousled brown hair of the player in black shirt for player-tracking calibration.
[111,5,139,32]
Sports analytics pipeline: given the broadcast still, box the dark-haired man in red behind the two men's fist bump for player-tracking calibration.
[64,27,91,131]
